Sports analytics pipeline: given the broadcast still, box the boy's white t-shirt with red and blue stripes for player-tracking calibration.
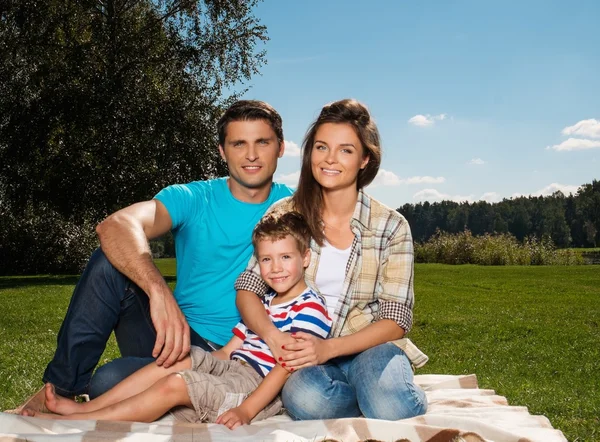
[231,288,331,377]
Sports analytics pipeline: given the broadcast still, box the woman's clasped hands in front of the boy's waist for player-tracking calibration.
[277,332,334,371]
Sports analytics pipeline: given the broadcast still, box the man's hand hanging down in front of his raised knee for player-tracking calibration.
[150,287,190,368]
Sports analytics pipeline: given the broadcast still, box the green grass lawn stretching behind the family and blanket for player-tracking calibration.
[0,260,600,442]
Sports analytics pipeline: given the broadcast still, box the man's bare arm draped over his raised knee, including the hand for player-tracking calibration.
[96,200,190,367]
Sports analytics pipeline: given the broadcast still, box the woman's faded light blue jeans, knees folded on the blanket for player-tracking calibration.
[282,343,427,420]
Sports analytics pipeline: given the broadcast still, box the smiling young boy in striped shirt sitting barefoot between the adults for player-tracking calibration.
[22,212,331,429]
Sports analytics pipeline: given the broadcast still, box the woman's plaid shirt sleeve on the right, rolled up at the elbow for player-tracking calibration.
[378,219,414,333]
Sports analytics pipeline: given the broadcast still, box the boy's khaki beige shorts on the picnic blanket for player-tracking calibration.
[171,347,282,423]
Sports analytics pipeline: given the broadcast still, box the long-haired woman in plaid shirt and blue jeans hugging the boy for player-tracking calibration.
[236,99,427,420]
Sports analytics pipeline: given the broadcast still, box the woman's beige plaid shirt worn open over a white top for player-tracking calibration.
[235,190,414,337]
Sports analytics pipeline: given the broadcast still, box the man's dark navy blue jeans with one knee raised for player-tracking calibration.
[43,249,213,397]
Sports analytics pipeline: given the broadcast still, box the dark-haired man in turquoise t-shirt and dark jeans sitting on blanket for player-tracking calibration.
[12,100,292,409]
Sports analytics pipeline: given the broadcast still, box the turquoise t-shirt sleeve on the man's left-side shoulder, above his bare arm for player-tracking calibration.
[154,183,205,230]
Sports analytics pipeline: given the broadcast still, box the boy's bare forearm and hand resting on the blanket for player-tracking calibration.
[217,365,290,430]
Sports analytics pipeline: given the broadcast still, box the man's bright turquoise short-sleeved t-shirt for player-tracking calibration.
[154,178,292,345]
